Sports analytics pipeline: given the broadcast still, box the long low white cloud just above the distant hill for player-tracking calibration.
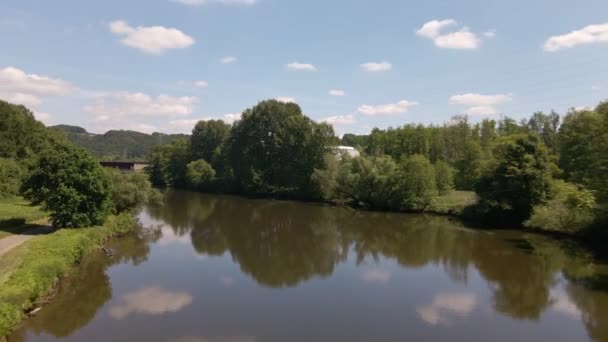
[85,92,198,118]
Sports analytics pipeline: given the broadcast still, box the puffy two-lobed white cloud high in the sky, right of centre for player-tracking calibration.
[416,19,482,50]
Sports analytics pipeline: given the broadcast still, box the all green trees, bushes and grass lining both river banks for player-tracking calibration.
[0,96,608,335]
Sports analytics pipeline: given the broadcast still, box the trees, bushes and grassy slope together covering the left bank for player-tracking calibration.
[0,101,156,336]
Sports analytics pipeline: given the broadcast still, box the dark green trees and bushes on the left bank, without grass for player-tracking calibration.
[0,100,158,228]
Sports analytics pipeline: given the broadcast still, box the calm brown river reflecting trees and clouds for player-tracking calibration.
[9,192,608,341]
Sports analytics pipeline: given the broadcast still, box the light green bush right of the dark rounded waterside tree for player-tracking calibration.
[526,180,596,233]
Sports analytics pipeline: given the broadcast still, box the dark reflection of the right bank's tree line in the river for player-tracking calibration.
[150,192,608,338]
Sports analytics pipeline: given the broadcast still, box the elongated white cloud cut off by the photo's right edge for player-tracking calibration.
[543,23,608,52]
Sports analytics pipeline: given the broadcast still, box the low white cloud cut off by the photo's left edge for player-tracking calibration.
[0,66,77,96]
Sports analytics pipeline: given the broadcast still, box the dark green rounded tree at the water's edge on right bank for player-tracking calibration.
[475,134,554,224]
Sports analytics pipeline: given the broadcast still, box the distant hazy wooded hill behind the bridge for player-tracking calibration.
[50,125,188,161]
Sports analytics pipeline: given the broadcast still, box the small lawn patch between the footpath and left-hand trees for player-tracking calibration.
[0,197,47,239]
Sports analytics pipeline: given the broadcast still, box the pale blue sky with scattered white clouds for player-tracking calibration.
[0,0,608,133]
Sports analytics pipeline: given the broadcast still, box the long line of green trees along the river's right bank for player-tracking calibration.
[147,100,608,233]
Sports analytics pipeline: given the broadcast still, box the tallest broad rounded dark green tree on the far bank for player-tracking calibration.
[226,100,334,197]
